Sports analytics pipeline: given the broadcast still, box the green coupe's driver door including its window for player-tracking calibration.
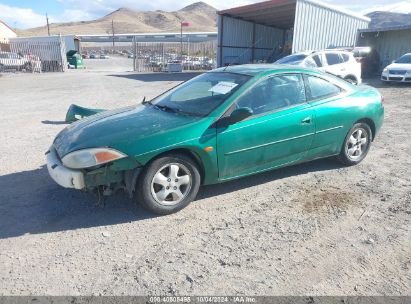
[217,74,314,180]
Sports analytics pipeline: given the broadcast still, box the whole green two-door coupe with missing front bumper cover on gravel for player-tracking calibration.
[46,65,384,214]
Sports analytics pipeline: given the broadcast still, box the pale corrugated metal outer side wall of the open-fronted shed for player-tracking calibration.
[292,0,368,53]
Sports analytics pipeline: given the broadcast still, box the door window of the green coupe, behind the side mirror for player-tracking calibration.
[236,74,306,115]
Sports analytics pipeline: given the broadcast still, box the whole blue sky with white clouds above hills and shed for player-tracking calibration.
[0,0,411,29]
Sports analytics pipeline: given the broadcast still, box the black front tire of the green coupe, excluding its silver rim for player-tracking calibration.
[136,154,201,215]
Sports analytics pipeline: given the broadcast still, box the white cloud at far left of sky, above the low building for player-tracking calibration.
[0,4,46,28]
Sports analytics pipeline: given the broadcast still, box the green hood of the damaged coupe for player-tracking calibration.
[53,105,200,158]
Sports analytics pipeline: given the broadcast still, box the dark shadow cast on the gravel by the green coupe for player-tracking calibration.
[0,159,341,239]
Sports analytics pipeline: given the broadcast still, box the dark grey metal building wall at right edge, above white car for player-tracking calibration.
[357,29,411,70]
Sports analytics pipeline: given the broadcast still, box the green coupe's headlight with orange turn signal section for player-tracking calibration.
[62,148,127,169]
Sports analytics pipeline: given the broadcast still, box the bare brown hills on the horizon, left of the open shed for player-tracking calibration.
[17,2,217,36]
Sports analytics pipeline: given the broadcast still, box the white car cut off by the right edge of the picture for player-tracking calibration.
[381,53,411,83]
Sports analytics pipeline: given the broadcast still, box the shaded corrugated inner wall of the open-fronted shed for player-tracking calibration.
[217,16,284,66]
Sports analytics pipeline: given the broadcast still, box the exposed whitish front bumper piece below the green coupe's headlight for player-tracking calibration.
[46,147,85,190]
